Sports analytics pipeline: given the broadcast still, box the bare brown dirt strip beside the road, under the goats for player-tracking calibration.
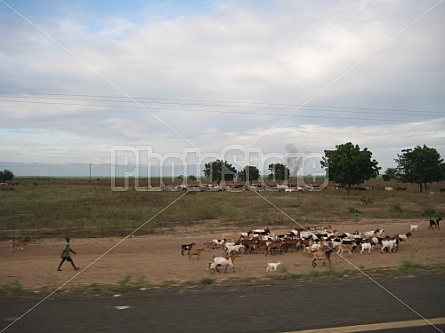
[0,220,445,289]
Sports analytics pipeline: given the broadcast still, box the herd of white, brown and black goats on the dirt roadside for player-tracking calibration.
[181,217,442,274]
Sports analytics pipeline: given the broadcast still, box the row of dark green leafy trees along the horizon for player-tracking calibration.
[204,142,445,192]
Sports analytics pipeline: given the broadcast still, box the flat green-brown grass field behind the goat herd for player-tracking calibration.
[0,178,445,239]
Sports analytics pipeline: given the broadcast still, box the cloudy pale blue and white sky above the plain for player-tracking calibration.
[0,0,445,173]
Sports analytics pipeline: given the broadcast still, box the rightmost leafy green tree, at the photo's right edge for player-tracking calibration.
[395,145,445,192]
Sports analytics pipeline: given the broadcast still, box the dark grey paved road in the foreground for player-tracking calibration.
[0,272,445,333]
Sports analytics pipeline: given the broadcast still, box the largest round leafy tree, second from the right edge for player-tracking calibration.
[320,142,381,193]
